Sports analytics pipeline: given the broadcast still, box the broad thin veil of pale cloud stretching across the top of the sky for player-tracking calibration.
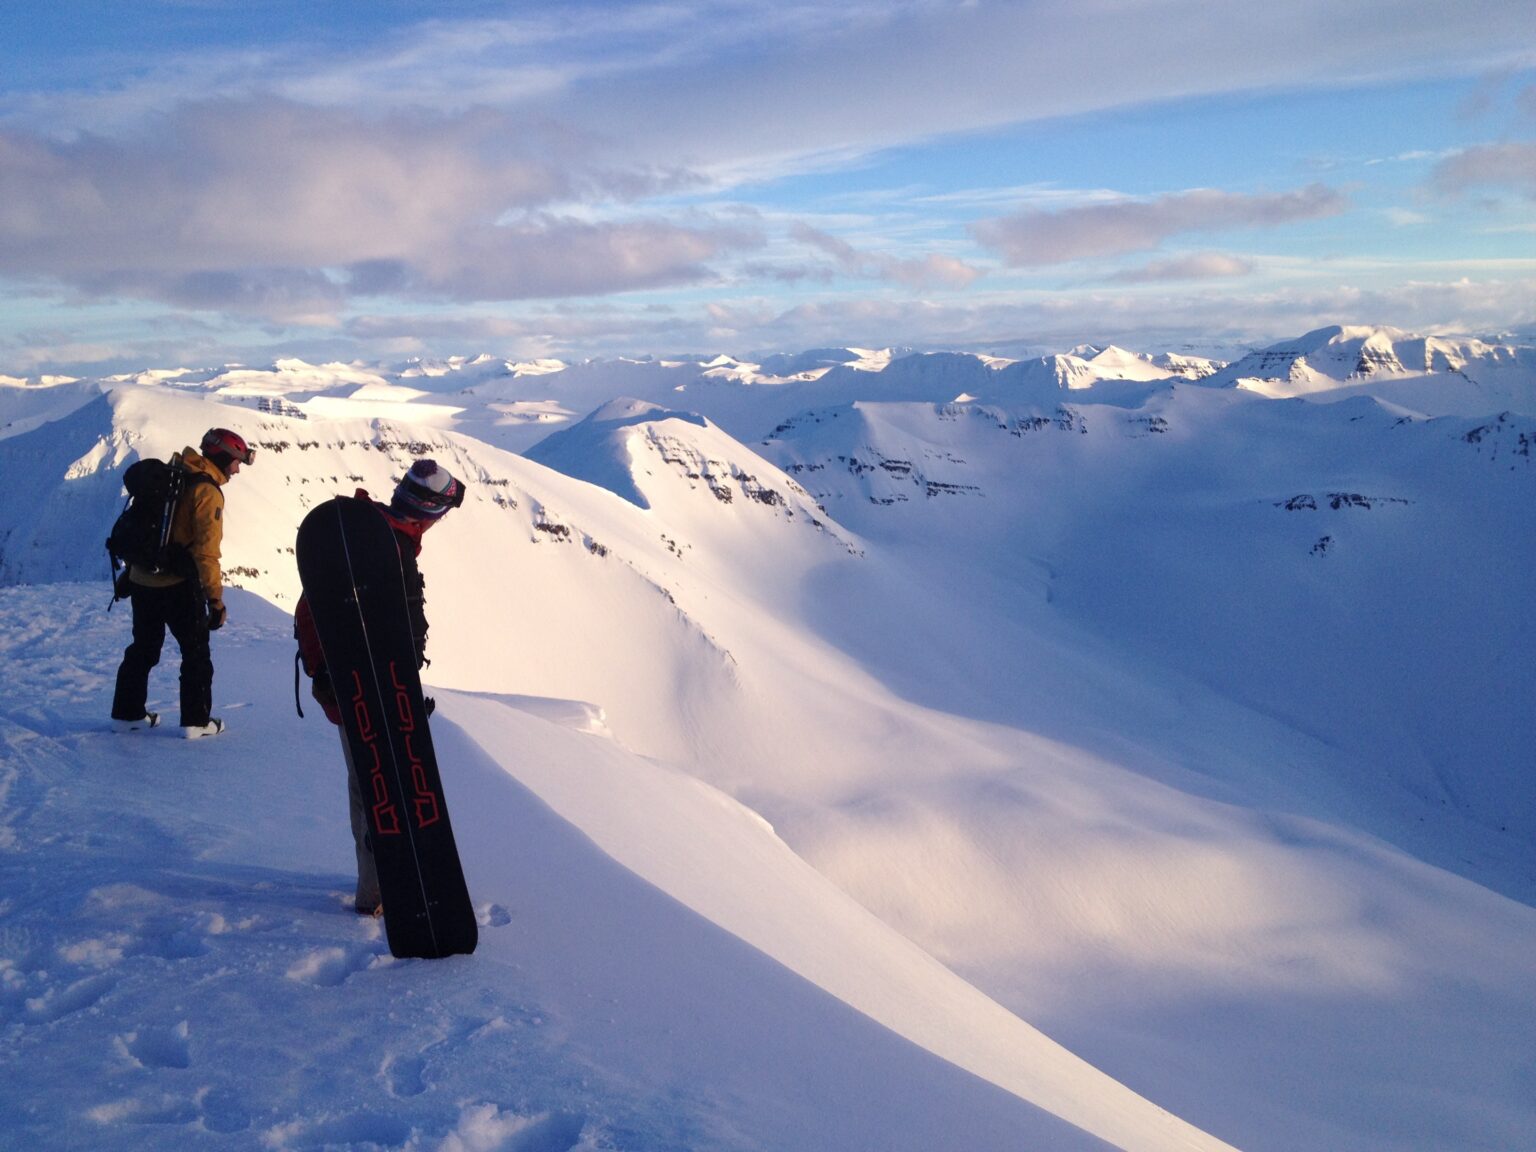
[0,0,1530,190]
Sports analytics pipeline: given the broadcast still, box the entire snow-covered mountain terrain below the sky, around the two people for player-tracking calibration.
[0,329,1536,1152]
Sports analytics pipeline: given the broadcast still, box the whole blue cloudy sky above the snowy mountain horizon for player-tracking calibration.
[0,0,1536,376]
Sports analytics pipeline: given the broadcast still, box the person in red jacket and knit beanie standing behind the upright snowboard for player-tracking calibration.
[293,459,464,915]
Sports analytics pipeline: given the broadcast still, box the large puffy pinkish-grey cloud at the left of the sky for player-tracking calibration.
[0,100,576,272]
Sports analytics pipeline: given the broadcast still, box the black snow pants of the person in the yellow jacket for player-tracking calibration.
[112,581,214,728]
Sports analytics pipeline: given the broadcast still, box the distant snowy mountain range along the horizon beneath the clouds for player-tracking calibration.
[9,326,1536,452]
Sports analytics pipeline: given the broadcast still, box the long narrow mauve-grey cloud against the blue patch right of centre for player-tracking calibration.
[971,184,1347,267]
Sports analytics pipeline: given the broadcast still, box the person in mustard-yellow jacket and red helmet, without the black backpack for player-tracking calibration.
[112,429,257,739]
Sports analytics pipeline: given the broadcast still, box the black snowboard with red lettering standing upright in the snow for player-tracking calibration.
[295,496,479,957]
